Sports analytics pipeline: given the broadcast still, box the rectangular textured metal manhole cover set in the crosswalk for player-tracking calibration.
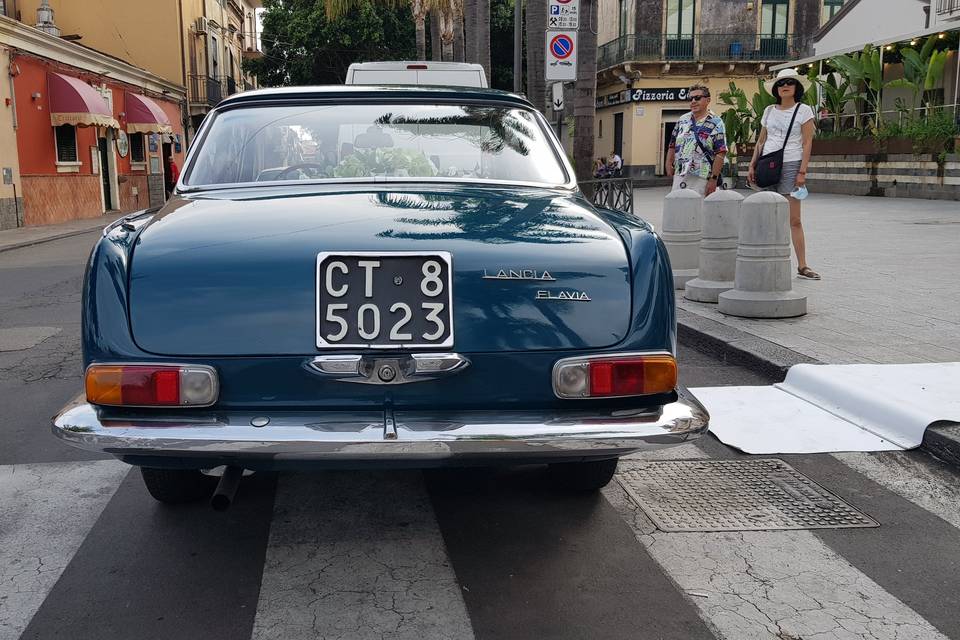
[617,458,880,531]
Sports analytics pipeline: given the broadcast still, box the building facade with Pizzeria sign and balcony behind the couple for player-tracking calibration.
[595,0,842,177]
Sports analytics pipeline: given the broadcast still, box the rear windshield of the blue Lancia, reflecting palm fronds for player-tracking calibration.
[184,104,567,186]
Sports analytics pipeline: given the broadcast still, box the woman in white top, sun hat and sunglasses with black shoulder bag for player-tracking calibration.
[748,69,820,280]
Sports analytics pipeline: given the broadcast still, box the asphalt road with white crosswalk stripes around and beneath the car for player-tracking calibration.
[0,234,960,640]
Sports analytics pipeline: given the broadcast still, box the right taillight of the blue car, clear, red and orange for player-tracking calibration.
[553,354,677,398]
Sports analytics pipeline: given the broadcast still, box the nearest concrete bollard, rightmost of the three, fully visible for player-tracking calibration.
[719,191,807,318]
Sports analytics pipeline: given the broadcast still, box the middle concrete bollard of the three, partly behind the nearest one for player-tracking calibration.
[683,190,743,303]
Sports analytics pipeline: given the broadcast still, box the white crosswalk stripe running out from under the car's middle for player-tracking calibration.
[253,472,473,640]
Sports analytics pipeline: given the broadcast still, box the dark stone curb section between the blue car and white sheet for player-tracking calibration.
[677,307,824,382]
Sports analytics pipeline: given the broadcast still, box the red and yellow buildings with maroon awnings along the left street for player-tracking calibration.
[0,0,261,229]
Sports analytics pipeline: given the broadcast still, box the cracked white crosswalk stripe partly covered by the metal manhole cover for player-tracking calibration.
[604,444,946,640]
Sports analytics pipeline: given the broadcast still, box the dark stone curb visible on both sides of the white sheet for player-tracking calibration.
[677,308,960,469]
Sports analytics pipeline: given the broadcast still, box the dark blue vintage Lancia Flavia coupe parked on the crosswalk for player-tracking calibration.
[54,86,708,504]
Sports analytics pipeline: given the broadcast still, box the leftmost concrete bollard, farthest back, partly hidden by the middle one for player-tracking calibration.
[660,189,703,289]
